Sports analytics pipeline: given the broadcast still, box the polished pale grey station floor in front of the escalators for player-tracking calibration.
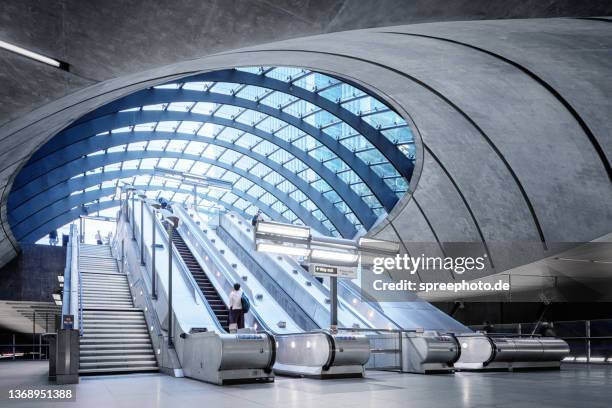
[0,361,612,408]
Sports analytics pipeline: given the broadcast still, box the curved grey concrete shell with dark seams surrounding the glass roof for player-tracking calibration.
[0,19,612,280]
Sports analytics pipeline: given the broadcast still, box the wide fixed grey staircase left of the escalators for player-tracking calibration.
[79,244,158,375]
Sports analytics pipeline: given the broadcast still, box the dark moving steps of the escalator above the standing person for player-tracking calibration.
[172,230,229,331]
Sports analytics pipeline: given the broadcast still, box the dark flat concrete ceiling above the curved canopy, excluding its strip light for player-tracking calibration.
[0,0,612,124]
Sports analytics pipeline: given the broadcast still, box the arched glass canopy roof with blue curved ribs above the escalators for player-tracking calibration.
[9,67,415,239]
